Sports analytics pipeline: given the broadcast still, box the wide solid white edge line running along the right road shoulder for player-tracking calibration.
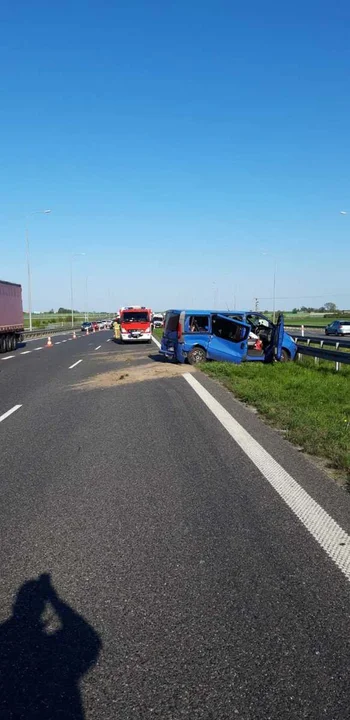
[183,373,350,580]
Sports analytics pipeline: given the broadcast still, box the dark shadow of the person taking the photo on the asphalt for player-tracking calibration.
[0,575,101,720]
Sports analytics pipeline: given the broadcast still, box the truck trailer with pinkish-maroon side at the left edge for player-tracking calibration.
[0,280,24,353]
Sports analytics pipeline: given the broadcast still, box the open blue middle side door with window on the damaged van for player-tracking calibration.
[207,315,250,363]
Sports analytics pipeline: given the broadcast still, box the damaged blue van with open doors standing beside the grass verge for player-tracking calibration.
[160,310,297,365]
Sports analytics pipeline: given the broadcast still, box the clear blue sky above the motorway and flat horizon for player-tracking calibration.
[0,0,350,311]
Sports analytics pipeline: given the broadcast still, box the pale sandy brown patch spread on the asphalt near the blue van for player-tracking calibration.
[75,362,194,390]
